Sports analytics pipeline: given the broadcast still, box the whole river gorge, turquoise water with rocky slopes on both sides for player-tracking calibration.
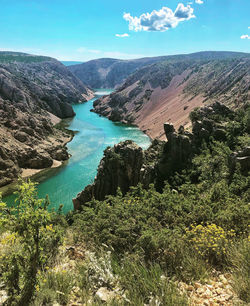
[0,52,249,212]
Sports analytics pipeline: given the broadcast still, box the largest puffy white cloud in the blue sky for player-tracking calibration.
[123,3,195,32]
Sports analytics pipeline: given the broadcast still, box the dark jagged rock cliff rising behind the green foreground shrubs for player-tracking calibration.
[73,102,250,209]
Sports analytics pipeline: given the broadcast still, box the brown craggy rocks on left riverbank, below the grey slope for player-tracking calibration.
[0,98,71,187]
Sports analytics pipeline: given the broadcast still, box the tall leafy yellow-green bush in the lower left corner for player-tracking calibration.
[0,181,66,305]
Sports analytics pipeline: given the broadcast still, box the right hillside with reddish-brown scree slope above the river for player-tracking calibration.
[94,52,250,139]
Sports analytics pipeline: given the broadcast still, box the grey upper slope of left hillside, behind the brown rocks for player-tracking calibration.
[0,52,92,118]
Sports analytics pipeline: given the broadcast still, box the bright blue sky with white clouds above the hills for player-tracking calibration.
[0,0,250,61]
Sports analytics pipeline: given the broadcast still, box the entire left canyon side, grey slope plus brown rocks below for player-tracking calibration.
[0,52,92,186]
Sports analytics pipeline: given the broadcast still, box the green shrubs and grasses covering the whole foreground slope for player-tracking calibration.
[0,104,250,305]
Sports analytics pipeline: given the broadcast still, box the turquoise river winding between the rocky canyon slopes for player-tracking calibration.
[4,89,150,213]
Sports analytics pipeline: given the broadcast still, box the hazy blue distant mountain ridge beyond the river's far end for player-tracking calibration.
[68,52,249,88]
